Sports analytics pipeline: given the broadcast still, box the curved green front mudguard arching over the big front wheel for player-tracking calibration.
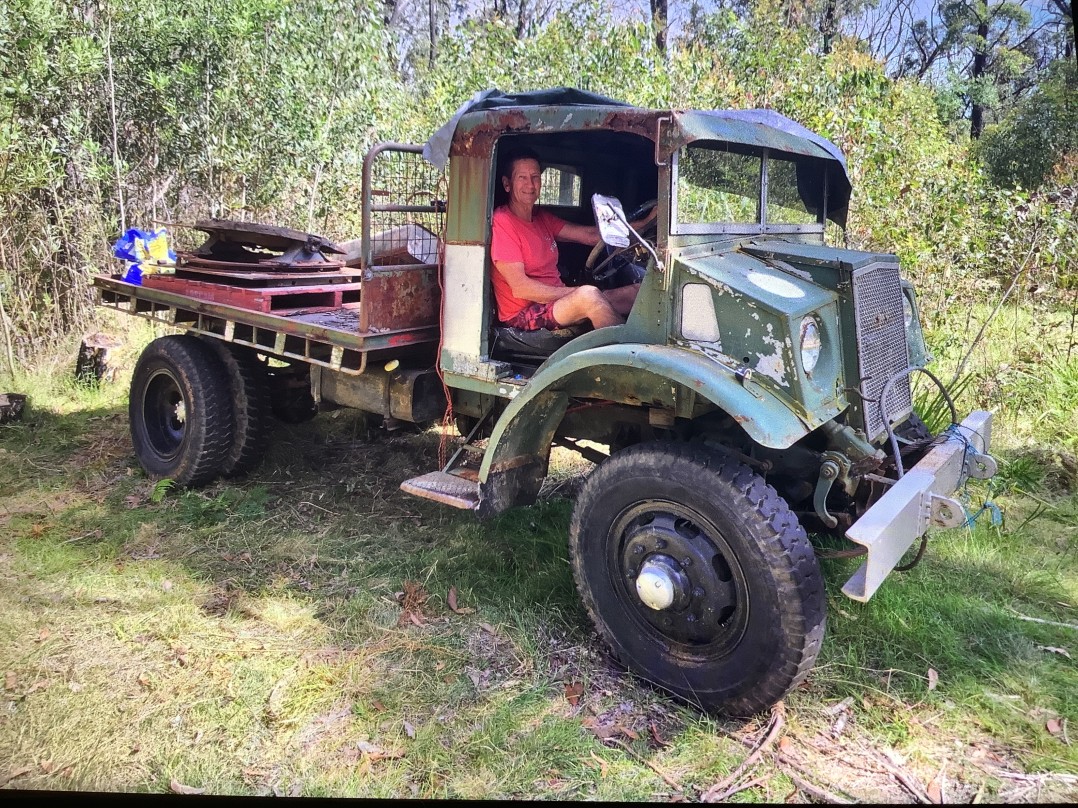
[479,344,818,515]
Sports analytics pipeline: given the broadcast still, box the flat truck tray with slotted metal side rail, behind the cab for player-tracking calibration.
[94,275,438,374]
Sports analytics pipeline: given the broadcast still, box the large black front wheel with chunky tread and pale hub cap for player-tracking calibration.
[569,442,826,715]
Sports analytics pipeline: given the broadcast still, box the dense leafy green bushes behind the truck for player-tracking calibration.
[0,0,1078,374]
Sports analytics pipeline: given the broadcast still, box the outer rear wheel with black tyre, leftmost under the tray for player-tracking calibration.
[128,336,233,487]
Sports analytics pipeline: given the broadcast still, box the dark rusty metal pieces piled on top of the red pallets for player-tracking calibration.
[179,219,345,269]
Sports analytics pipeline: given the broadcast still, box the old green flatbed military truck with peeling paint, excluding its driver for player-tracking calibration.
[96,89,995,714]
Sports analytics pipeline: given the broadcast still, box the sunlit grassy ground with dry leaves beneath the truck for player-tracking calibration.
[0,305,1078,802]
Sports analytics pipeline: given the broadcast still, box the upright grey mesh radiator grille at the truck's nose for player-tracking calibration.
[854,264,912,441]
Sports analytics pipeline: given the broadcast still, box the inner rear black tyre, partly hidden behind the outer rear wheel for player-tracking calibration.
[201,337,271,477]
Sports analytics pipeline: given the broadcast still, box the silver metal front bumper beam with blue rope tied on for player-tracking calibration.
[842,409,995,603]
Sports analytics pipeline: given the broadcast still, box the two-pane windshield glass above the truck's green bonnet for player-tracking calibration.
[676,142,825,232]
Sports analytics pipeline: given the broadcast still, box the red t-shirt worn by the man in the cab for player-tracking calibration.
[490,205,566,322]
